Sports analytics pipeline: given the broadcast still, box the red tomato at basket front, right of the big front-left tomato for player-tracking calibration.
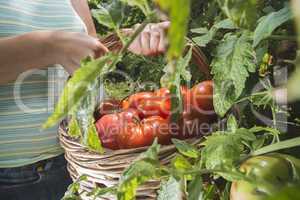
[141,116,171,145]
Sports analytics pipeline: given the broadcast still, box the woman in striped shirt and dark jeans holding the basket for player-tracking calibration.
[0,0,168,200]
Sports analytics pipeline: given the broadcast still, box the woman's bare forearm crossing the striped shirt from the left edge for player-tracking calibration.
[0,32,53,84]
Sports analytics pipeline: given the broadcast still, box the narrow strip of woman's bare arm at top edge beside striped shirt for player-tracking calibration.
[71,0,97,37]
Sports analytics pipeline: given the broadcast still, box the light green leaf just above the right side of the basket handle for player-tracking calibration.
[193,19,237,47]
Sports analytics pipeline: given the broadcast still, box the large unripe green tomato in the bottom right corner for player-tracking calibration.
[230,153,300,200]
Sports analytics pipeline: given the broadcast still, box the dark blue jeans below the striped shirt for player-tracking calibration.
[0,156,72,200]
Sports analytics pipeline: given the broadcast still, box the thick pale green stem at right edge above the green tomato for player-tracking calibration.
[252,137,300,156]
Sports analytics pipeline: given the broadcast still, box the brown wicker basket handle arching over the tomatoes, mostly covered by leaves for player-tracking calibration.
[100,33,211,80]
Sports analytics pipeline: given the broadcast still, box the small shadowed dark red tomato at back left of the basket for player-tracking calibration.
[94,99,121,121]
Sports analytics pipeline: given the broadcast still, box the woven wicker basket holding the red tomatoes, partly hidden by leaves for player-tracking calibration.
[58,33,210,200]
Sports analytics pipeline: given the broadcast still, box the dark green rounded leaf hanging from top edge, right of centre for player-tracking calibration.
[217,0,257,29]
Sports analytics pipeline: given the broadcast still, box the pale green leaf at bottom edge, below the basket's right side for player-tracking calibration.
[157,177,184,200]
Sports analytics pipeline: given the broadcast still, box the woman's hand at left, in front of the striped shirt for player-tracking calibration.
[45,31,108,74]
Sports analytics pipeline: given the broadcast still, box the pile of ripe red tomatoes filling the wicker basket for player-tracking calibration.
[95,81,214,149]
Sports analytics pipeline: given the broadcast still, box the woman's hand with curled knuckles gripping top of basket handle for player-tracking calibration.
[129,21,170,56]
